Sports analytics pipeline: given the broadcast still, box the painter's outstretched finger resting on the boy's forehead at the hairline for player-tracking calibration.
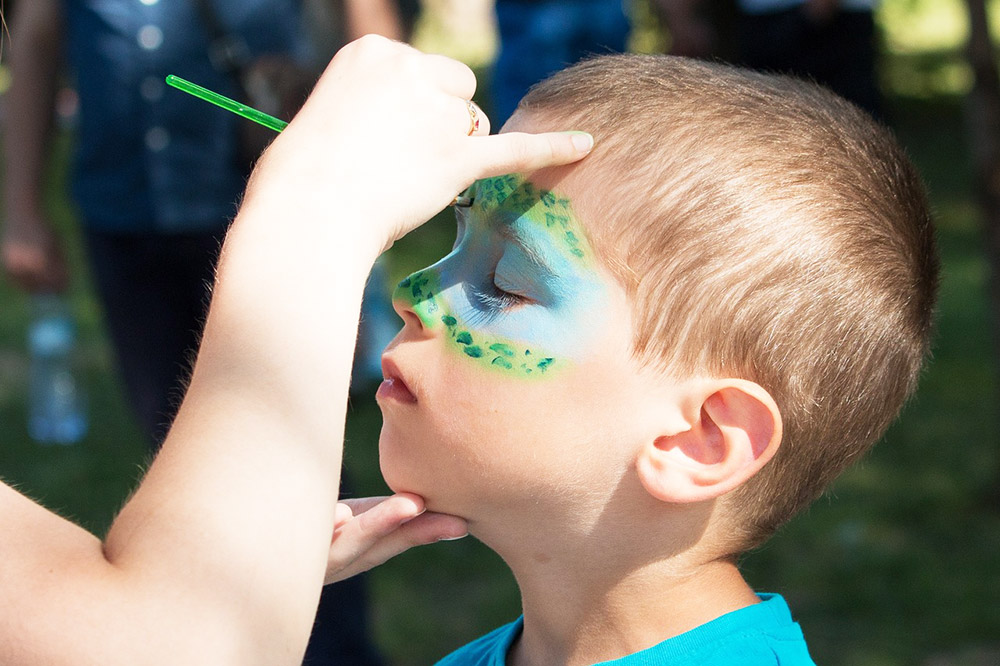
[473,132,594,179]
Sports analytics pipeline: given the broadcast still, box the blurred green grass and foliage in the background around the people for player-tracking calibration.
[0,0,1000,666]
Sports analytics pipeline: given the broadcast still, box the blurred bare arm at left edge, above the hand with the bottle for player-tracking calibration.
[3,0,62,219]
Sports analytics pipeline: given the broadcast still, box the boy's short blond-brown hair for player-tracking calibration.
[518,55,938,554]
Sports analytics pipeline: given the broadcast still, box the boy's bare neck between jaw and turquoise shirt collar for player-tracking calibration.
[470,493,759,666]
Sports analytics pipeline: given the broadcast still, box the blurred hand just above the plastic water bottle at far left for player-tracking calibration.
[0,219,69,292]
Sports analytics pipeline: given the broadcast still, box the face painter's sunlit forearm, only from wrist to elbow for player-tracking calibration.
[105,191,370,664]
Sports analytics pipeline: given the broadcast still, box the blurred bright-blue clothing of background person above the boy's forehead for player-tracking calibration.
[491,0,631,127]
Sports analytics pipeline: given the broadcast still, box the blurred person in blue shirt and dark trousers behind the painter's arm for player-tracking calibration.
[2,0,405,666]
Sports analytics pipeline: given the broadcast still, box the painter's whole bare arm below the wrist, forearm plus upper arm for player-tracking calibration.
[0,192,374,666]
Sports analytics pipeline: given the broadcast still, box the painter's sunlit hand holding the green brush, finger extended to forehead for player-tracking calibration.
[244,35,592,259]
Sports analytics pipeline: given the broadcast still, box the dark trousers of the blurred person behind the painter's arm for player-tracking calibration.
[85,230,382,666]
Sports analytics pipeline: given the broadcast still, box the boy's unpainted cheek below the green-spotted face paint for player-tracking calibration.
[379,340,640,517]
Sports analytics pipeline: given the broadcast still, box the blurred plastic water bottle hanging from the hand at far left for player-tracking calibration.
[28,294,87,444]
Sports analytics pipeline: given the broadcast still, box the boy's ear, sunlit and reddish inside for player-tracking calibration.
[636,379,781,503]
